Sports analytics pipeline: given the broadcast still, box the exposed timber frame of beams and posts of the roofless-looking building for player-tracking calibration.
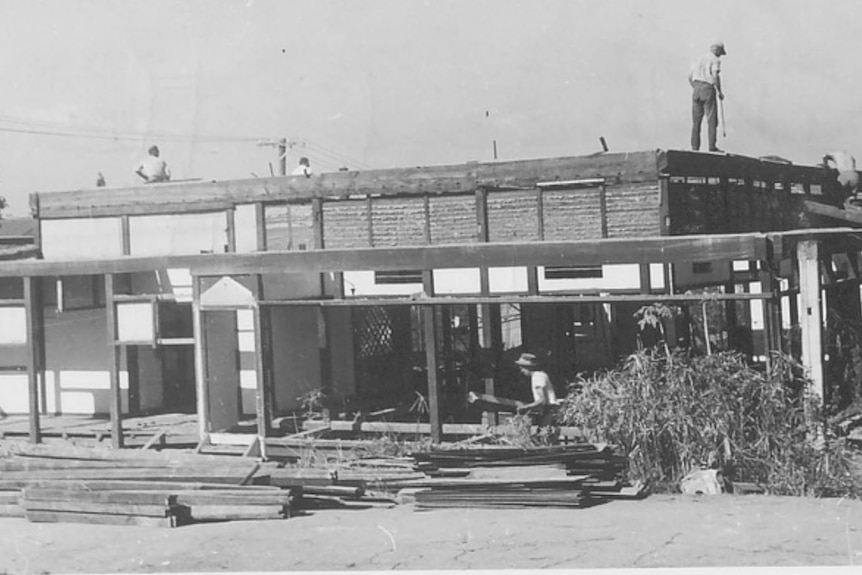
[6,150,862,447]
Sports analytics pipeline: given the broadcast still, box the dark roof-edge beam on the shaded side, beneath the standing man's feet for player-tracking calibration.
[658,150,828,185]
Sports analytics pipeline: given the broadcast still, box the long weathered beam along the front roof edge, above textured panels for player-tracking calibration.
[30,151,658,219]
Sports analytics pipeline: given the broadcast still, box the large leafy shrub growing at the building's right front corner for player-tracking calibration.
[562,349,859,495]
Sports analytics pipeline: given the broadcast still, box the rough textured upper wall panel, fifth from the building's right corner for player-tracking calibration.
[371,198,426,247]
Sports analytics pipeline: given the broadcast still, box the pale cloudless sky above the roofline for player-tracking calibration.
[0,0,862,216]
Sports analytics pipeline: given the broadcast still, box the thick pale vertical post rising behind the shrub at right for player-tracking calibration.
[796,240,824,404]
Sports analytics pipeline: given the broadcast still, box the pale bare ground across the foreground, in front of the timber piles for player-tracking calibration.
[0,495,862,574]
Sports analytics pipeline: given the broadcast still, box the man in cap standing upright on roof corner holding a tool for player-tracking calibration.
[688,42,727,152]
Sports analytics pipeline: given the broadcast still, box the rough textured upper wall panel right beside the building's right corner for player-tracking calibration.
[605,185,661,238]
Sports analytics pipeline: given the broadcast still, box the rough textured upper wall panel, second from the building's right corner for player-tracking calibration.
[543,188,602,240]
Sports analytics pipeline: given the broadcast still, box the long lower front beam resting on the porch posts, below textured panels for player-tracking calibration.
[0,234,768,277]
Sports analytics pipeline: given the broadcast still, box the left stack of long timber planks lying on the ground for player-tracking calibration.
[0,448,302,527]
